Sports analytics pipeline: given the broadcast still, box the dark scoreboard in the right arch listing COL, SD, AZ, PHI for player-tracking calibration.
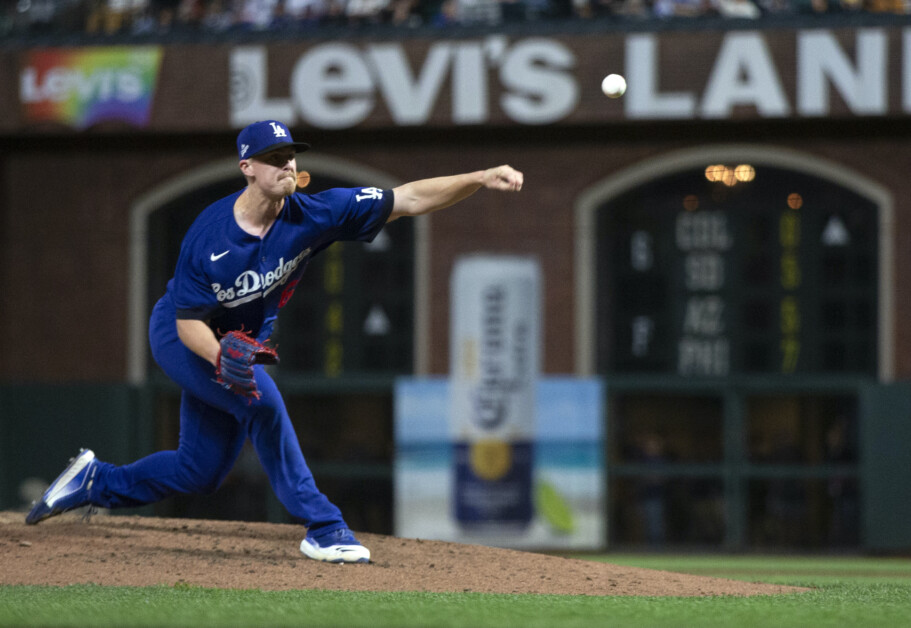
[596,164,879,377]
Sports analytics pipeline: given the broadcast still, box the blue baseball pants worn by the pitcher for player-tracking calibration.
[84,299,347,532]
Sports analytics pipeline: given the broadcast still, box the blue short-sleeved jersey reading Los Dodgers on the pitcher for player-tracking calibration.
[163,188,393,341]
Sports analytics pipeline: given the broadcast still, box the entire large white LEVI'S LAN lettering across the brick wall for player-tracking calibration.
[228,28,911,129]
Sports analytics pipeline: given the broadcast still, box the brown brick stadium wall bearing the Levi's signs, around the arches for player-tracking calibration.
[0,26,911,382]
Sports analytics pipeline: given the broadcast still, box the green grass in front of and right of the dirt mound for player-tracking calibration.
[0,555,911,628]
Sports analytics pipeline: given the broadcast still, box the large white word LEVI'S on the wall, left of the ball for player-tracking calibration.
[230,35,580,129]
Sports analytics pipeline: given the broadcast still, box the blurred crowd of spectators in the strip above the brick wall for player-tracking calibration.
[7,0,911,37]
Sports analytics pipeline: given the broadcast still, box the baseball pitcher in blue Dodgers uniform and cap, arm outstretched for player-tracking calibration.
[26,120,523,563]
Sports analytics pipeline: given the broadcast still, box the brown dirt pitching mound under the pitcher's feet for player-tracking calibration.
[0,512,803,596]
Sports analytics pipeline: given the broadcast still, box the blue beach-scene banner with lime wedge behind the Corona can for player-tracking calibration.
[394,377,607,550]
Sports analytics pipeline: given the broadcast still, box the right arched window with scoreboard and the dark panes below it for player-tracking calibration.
[576,147,894,549]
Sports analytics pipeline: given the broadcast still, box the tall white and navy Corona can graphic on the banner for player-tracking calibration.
[450,255,541,530]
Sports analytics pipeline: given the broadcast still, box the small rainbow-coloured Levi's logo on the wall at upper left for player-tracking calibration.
[19,46,162,129]
